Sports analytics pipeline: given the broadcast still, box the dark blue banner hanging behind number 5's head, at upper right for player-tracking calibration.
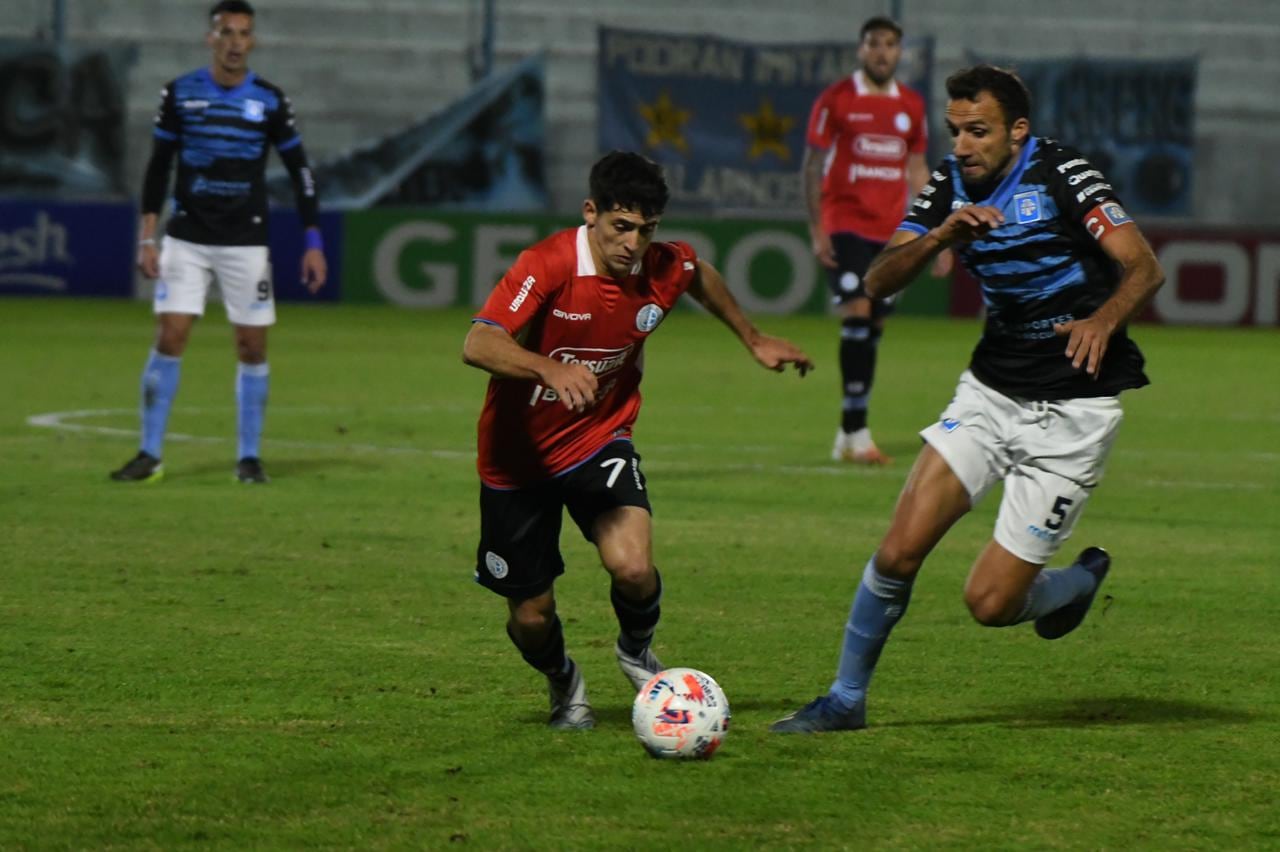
[974,56,1197,216]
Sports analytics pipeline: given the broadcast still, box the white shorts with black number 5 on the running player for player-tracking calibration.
[920,370,1124,565]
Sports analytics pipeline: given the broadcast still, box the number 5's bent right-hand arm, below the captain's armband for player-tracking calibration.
[1053,224,1165,379]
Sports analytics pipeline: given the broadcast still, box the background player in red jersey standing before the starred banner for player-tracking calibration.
[803,17,948,464]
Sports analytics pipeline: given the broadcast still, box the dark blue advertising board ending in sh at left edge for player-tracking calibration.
[0,197,137,298]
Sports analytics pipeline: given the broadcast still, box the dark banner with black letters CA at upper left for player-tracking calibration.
[0,40,137,197]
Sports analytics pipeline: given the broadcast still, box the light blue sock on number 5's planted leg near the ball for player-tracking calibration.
[831,556,914,709]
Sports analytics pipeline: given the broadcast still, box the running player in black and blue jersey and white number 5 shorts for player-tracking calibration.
[772,65,1164,733]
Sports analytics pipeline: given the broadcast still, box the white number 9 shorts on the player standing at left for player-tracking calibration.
[152,237,275,325]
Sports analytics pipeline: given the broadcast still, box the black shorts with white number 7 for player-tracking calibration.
[475,440,653,600]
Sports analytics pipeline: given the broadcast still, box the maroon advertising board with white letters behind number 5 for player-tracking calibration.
[951,226,1280,327]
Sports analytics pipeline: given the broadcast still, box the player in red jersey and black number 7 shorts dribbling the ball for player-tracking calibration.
[462,151,813,728]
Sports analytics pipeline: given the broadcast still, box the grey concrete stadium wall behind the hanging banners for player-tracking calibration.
[0,0,1280,225]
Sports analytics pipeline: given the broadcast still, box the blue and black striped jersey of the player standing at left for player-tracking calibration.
[155,68,302,246]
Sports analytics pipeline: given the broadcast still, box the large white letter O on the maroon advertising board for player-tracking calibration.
[1156,241,1249,325]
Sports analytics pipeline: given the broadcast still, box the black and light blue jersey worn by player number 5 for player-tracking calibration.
[899,137,1147,399]
